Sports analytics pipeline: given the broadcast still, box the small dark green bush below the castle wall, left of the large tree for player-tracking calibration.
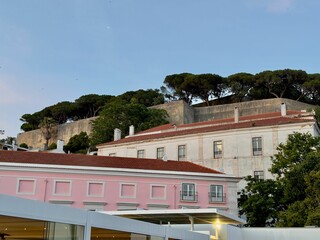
[63,132,90,154]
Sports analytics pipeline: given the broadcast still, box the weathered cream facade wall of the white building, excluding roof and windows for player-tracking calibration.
[98,120,319,189]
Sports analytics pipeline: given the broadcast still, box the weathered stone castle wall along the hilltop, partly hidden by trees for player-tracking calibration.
[17,98,315,148]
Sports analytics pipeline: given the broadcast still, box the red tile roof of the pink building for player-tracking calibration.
[0,150,223,174]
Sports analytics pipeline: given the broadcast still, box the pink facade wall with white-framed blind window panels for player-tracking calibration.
[0,171,227,211]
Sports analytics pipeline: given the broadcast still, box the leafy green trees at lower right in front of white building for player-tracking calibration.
[239,133,320,227]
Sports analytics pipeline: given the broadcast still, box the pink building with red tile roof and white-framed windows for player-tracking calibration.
[0,150,239,214]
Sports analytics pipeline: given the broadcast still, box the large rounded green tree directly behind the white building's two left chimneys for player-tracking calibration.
[91,99,167,146]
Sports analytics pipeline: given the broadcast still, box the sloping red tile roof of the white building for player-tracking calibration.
[97,111,315,148]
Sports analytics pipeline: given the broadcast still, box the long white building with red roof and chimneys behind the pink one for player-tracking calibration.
[97,104,319,188]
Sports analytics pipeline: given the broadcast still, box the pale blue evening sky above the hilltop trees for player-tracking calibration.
[0,0,320,139]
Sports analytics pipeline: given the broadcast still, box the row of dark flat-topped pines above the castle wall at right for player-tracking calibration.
[161,69,320,105]
